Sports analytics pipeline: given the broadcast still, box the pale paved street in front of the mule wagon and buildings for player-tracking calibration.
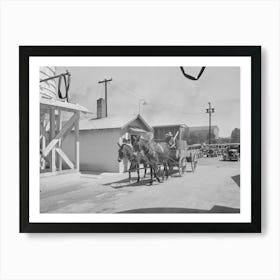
[40,158,240,213]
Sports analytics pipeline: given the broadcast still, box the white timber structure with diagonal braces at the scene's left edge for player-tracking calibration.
[40,67,88,177]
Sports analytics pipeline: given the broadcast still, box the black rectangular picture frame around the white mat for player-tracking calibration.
[19,46,261,233]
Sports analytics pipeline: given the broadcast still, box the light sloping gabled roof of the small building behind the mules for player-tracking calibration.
[77,115,153,131]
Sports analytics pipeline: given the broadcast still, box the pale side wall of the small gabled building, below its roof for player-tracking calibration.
[62,129,120,172]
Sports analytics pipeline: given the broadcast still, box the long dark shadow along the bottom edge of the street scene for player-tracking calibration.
[118,205,240,214]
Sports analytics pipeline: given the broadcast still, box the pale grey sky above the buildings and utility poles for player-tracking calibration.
[56,66,240,137]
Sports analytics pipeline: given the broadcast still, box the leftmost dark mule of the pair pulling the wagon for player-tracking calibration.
[118,144,148,182]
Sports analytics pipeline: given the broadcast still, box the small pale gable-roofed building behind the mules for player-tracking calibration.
[63,115,153,173]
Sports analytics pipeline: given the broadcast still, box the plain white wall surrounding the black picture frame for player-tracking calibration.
[0,0,280,280]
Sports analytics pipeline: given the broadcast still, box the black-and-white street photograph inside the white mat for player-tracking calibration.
[39,66,242,214]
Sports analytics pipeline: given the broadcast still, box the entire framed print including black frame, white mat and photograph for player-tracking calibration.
[20,46,260,232]
